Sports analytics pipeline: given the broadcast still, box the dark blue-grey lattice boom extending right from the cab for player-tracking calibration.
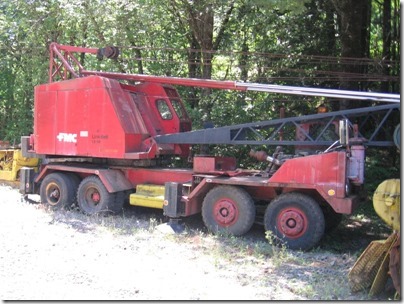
[155,104,400,147]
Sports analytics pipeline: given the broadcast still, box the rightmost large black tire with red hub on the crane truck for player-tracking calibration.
[264,192,325,250]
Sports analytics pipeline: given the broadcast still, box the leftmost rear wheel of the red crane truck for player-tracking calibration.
[39,172,76,210]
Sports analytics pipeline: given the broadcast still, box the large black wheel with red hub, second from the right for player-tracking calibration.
[202,186,256,236]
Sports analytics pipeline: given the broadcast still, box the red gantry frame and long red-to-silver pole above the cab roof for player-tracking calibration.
[49,43,400,103]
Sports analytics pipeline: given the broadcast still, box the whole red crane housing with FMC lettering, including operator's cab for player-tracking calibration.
[34,76,191,159]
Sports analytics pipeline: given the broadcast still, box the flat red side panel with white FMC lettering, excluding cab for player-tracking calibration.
[34,77,129,157]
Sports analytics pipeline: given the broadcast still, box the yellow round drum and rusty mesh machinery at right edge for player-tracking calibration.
[348,179,401,297]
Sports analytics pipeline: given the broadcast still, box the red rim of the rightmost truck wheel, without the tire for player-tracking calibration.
[276,208,308,239]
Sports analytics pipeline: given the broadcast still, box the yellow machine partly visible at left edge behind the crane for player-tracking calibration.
[0,149,39,181]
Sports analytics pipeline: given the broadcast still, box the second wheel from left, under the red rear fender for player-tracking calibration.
[77,175,115,215]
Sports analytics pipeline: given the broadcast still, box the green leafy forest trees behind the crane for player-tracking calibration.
[0,0,401,194]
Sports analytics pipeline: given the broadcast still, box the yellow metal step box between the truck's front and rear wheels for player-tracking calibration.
[129,185,165,209]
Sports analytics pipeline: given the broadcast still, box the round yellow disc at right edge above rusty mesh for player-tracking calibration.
[373,179,400,231]
